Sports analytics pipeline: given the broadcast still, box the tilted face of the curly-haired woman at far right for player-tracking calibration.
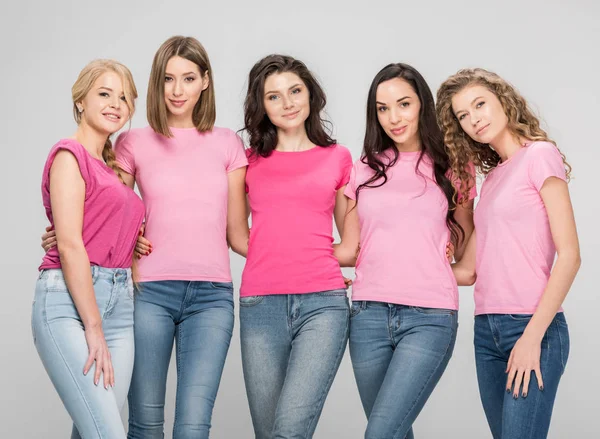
[452,85,508,144]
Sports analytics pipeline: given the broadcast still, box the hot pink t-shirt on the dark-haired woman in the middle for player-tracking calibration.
[240,145,352,297]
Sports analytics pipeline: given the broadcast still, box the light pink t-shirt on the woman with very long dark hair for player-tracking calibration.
[345,152,477,310]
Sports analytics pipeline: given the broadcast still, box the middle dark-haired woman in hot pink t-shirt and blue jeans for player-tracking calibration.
[240,55,352,439]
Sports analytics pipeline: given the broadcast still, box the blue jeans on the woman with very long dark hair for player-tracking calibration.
[349,301,458,439]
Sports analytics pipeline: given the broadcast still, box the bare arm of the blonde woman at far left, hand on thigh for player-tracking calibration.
[50,151,114,387]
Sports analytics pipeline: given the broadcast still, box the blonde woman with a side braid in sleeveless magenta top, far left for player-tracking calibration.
[32,60,144,439]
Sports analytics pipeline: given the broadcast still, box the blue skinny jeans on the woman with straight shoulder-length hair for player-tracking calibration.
[127,280,233,439]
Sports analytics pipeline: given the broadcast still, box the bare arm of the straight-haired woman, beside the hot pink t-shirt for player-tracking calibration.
[227,167,249,257]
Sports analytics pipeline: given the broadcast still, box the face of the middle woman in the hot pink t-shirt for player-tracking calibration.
[263,72,310,130]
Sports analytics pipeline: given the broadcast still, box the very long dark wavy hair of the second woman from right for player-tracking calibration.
[356,63,465,244]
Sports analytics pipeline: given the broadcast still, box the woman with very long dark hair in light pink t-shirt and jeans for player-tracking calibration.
[336,63,476,439]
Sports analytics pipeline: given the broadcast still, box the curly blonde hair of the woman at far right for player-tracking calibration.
[436,68,571,201]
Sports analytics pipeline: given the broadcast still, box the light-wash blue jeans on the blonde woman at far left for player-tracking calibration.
[31,266,134,439]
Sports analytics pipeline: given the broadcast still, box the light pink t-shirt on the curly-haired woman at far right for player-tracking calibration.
[475,142,566,315]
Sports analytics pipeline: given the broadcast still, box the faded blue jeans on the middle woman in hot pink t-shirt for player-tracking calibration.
[240,290,349,439]
